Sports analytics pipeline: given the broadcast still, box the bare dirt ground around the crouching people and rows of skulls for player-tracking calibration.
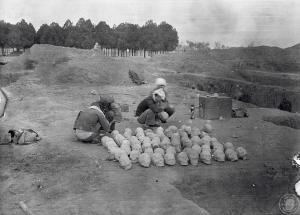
[0,47,300,215]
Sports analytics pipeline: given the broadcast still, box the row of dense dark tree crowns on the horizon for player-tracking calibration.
[0,18,178,52]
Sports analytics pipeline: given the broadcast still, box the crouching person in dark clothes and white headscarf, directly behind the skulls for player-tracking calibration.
[136,89,174,127]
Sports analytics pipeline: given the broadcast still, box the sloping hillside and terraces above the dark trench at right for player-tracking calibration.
[153,46,300,91]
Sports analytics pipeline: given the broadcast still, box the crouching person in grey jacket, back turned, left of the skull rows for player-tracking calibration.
[73,96,122,142]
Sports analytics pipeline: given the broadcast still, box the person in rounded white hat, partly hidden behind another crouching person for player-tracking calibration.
[150,78,175,123]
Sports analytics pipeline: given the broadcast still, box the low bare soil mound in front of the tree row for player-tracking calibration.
[1,44,154,85]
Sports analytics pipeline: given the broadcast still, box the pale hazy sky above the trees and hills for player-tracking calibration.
[0,0,300,48]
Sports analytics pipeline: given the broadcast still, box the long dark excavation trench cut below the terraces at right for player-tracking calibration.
[167,74,300,112]
